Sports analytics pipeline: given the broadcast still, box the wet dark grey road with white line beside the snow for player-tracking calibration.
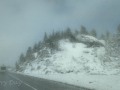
[0,72,93,90]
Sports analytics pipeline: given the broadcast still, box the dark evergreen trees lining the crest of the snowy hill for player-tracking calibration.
[16,25,120,70]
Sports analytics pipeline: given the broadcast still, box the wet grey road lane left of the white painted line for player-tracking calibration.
[0,72,33,90]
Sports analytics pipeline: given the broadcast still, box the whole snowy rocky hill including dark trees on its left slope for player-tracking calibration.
[16,29,120,74]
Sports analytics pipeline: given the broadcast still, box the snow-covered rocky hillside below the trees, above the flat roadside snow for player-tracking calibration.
[17,35,120,74]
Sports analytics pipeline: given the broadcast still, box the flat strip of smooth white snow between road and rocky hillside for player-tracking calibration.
[20,73,120,90]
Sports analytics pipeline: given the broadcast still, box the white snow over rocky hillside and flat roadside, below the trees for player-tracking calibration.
[17,35,120,90]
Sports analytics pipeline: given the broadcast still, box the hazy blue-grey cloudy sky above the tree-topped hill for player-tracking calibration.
[0,0,120,65]
